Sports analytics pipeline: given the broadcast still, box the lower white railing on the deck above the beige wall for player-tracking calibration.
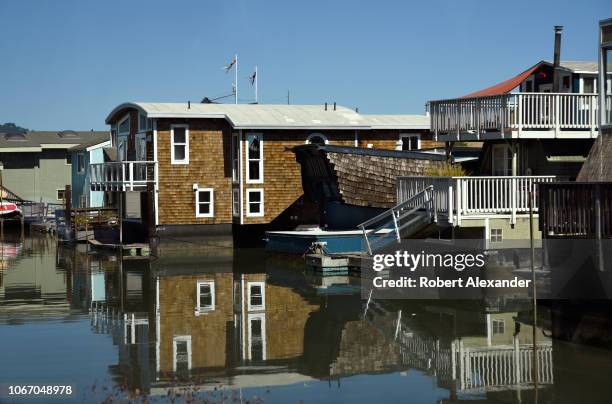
[397,175,556,226]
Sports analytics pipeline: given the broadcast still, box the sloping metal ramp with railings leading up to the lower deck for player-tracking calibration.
[357,185,438,255]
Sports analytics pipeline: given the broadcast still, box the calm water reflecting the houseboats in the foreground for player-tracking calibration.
[0,237,612,403]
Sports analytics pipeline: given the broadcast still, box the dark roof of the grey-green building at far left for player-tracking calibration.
[0,130,110,153]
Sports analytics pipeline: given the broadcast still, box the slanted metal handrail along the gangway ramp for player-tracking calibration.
[357,185,438,255]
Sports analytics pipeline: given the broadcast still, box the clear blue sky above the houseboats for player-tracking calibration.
[0,0,612,130]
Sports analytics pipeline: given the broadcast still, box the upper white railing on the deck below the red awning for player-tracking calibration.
[429,93,610,138]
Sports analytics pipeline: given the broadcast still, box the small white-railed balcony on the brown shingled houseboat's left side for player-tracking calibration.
[89,161,157,191]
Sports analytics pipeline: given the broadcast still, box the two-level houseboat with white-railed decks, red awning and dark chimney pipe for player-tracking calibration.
[397,27,610,246]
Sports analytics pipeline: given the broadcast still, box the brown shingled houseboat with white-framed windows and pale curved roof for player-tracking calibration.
[91,102,442,243]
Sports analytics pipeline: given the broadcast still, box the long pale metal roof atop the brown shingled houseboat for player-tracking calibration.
[106,102,429,129]
